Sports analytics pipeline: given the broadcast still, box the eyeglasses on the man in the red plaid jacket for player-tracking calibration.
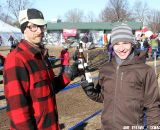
[27,24,47,32]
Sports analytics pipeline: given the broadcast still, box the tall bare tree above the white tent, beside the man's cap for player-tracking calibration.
[6,0,31,20]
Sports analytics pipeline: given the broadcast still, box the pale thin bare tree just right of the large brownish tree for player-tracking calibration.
[132,1,149,25]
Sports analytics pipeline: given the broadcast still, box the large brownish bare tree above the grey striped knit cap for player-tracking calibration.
[99,0,132,22]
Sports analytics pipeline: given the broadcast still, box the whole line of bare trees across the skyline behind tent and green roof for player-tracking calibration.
[0,0,160,32]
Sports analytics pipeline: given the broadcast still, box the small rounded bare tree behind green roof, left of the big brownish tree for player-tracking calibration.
[65,8,84,23]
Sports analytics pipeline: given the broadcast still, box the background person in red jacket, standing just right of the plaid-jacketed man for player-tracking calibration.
[60,46,70,74]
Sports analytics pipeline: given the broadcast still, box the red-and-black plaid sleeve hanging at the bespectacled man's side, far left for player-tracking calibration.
[4,54,35,130]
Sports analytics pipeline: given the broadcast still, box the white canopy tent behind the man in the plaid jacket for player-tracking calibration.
[0,20,22,46]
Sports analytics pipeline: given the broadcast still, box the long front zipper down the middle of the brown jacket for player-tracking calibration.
[113,65,119,126]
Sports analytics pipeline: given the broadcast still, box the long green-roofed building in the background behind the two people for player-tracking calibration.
[47,22,142,46]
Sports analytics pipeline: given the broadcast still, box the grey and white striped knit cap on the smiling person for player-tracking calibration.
[111,24,134,46]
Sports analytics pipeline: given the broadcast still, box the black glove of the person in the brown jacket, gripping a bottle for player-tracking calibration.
[80,77,94,91]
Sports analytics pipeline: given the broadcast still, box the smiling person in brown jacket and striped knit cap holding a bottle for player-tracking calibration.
[81,25,160,130]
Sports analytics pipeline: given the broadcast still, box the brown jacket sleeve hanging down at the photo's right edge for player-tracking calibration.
[144,68,160,129]
